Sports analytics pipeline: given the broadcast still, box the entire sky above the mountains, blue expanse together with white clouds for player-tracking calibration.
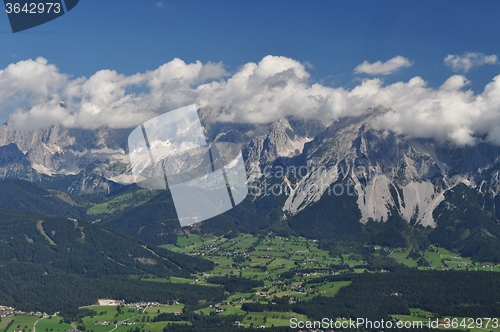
[0,0,500,145]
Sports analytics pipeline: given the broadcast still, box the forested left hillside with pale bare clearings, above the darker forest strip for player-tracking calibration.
[0,210,213,277]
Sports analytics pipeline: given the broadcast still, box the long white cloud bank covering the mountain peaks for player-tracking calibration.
[0,56,500,145]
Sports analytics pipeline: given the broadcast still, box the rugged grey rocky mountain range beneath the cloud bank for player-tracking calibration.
[0,106,500,259]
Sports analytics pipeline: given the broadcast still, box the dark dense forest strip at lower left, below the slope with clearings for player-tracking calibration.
[0,262,224,314]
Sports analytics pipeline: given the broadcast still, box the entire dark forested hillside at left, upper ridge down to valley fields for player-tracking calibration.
[0,180,223,313]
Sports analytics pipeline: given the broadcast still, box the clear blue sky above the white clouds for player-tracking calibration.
[0,0,500,90]
